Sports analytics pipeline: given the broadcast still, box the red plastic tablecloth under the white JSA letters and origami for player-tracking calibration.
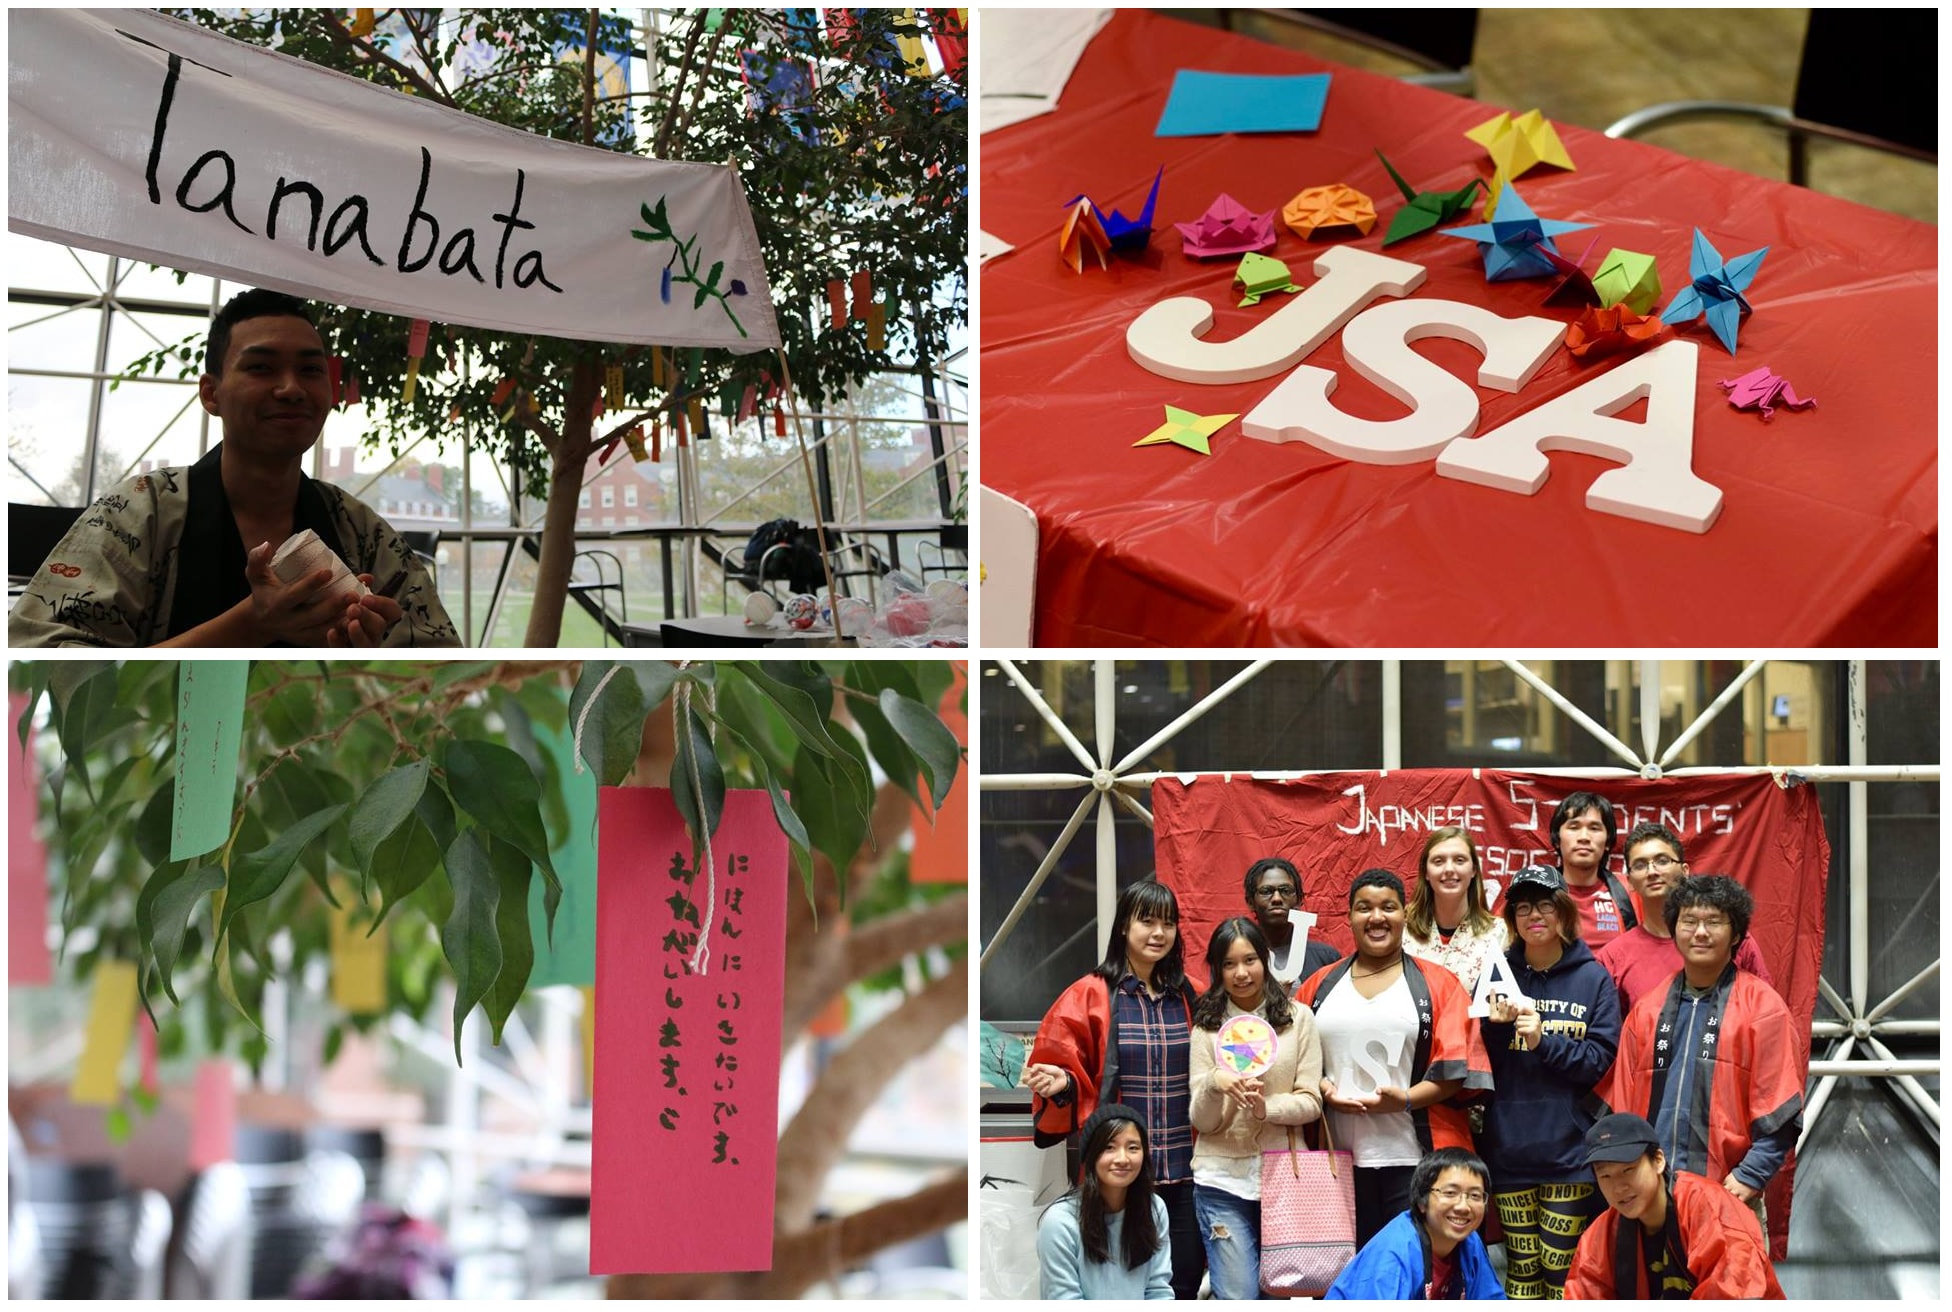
[980,10,1938,646]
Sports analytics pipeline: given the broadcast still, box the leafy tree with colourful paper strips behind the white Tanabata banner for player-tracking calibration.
[129,8,968,646]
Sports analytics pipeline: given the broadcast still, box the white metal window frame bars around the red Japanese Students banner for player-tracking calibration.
[976,658,1942,1148]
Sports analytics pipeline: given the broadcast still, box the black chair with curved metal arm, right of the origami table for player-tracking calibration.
[1606,10,1938,187]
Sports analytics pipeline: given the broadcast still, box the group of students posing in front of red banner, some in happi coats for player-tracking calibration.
[1023,793,1804,1298]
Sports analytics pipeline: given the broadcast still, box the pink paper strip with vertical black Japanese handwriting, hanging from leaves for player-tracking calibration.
[590,789,789,1275]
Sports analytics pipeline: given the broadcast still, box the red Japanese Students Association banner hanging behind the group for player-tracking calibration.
[1152,769,1831,1257]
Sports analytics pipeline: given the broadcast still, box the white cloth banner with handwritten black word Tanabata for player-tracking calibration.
[8,10,779,351]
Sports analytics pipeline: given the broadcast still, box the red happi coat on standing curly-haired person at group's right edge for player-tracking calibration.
[1595,963,1806,1183]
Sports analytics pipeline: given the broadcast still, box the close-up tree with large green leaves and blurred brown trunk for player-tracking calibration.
[12,660,968,1296]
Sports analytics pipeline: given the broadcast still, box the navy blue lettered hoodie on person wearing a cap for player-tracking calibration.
[1478,941,1620,1191]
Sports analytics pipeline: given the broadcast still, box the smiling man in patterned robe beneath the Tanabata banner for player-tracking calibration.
[8,291,459,646]
